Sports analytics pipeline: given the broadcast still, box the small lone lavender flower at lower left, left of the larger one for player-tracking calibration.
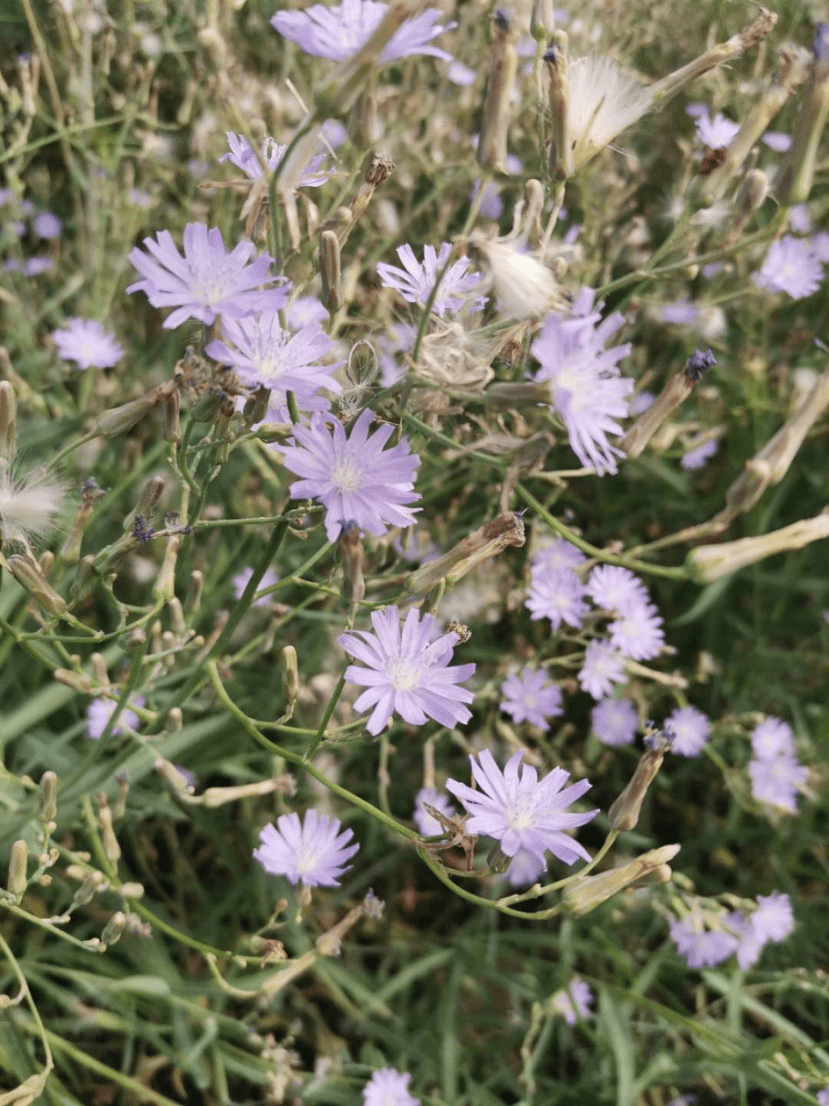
[253,810,359,887]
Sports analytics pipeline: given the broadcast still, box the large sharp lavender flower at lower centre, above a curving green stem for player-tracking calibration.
[447,749,599,864]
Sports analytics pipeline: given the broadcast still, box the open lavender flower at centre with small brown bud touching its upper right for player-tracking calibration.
[337,607,475,733]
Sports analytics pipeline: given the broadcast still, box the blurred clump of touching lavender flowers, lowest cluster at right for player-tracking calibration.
[670,891,795,970]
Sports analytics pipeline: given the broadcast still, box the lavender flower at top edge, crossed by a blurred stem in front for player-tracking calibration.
[271,0,455,62]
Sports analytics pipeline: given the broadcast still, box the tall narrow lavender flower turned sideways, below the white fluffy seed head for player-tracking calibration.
[531,289,634,473]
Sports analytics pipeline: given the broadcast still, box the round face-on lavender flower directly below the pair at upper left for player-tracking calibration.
[280,408,420,542]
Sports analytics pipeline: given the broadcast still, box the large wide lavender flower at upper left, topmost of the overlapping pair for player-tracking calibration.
[127,222,287,330]
